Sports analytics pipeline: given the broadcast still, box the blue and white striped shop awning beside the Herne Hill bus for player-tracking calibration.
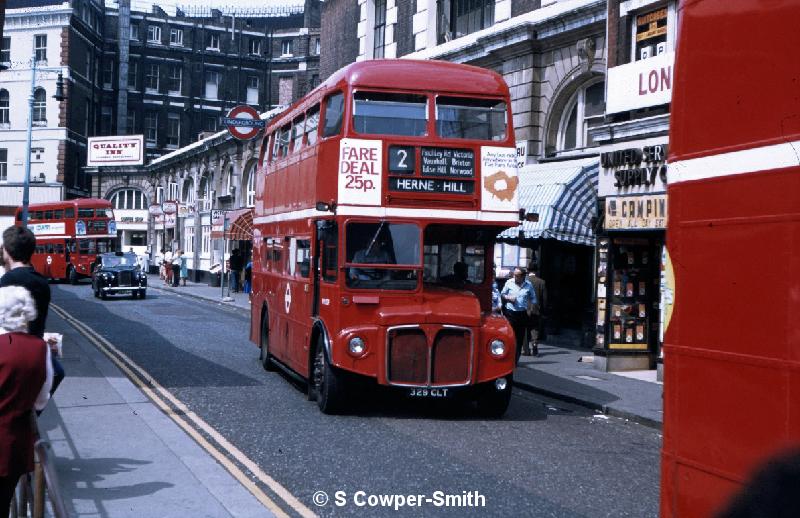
[498,158,600,246]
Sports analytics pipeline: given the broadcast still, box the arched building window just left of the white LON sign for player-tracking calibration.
[558,81,605,151]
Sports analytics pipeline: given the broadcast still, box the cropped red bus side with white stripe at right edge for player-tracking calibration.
[661,0,800,517]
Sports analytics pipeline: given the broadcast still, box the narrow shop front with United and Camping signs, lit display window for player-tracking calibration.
[594,143,667,371]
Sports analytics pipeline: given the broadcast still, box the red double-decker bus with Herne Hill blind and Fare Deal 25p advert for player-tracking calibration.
[250,60,519,416]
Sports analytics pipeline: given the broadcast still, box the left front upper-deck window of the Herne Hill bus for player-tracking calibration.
[353,92,428,137]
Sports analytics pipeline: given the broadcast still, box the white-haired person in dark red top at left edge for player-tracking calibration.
[0,286,53,518]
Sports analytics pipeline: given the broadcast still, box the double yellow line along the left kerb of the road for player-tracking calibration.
[50,303,316,518]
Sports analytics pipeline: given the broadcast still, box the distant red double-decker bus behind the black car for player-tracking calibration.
[15,198,117,284]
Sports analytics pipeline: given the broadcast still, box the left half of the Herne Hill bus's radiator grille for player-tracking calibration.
[387,329,428,385]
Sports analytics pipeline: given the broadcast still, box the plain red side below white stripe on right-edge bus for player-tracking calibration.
[661,168,800,516]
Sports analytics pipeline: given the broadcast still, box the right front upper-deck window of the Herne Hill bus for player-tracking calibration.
[436,97,507,141]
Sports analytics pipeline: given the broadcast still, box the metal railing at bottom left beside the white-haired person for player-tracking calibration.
[10,412,69,518]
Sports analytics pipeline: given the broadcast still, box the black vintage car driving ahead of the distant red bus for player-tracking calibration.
[92,252,147,298]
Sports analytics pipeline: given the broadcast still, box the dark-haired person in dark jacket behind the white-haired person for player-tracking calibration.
[0,226,65,394]
